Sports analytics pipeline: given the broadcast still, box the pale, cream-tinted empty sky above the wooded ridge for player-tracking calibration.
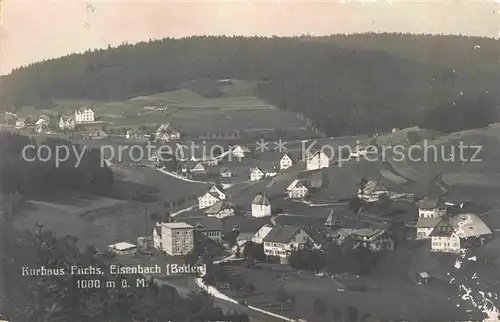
[0,0,500,74]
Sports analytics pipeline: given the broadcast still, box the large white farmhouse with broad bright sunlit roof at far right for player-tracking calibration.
[429,214,492,253]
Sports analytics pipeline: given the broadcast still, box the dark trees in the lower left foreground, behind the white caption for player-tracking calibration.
[6,227,248,322]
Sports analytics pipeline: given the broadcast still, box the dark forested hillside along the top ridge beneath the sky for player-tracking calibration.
[2,34,500,135]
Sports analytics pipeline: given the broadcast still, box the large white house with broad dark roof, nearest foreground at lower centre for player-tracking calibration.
[263,225,314,259]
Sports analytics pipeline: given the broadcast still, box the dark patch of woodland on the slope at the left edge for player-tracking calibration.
[0,132,114,197]
